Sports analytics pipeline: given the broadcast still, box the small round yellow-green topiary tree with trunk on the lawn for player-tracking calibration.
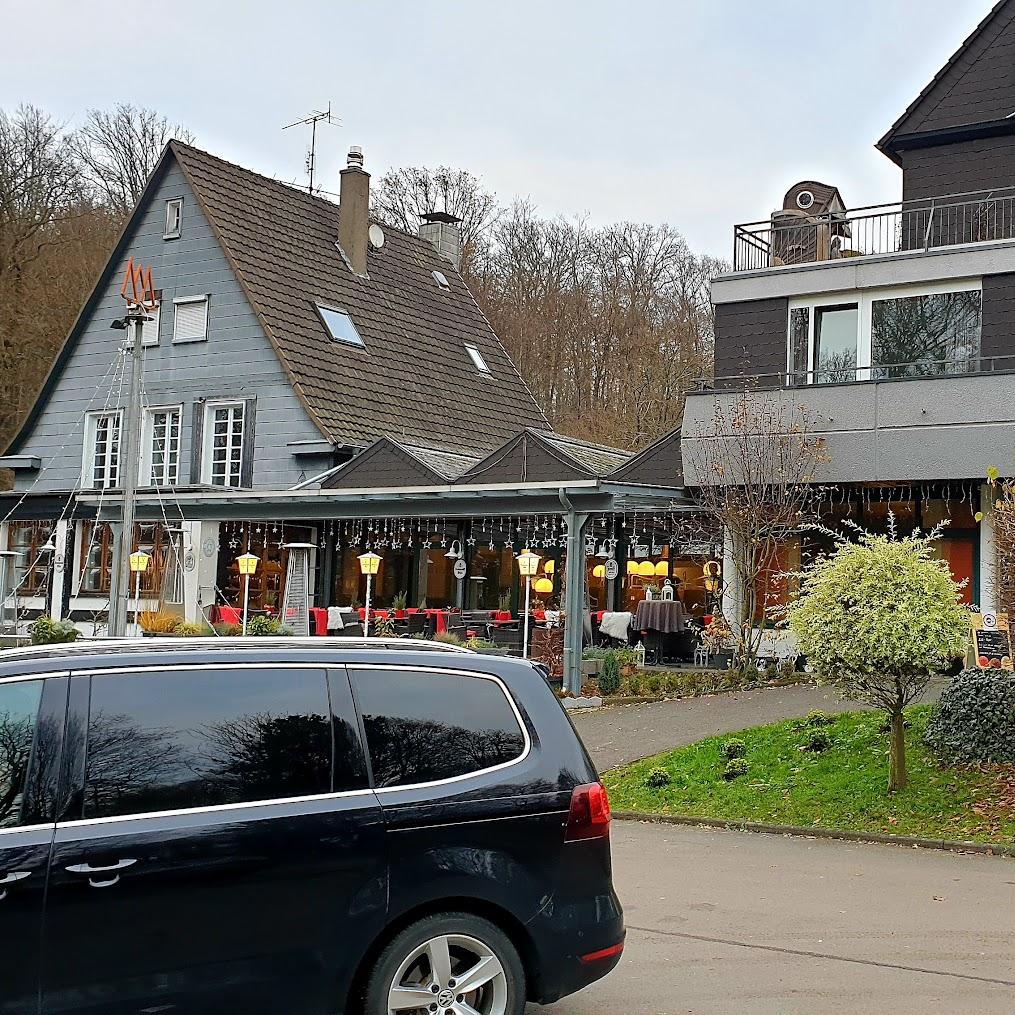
[789,532,969,792]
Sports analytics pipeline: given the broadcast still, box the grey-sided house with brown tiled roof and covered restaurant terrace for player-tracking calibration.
[0,142,700,657]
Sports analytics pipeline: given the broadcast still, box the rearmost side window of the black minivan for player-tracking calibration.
[350,669,525,787]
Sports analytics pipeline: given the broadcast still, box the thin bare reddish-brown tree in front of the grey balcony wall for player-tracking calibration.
[684,389,828,665]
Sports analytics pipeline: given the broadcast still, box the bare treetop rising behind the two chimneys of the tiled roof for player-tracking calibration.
[370,165,500,275]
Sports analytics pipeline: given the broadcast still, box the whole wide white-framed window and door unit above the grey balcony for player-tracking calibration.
[787,279,983,385]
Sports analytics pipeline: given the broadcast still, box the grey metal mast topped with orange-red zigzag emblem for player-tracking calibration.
[107,258,158,637]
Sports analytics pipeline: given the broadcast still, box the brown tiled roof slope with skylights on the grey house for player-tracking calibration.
[170,141,549,454]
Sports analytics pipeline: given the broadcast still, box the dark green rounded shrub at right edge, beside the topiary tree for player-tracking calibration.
[924,670,1015,764]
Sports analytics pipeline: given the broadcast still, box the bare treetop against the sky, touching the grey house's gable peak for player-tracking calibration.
[71,103,194,218]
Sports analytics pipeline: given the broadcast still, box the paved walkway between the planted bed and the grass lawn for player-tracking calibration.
[572,684,943,771]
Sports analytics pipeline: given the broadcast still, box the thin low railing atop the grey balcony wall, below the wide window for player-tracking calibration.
[694,354,1015,391]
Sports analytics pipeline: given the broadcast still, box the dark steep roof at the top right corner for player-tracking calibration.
[877,0,1015,161]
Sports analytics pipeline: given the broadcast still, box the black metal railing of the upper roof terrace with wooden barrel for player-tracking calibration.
[733,187,1015,271]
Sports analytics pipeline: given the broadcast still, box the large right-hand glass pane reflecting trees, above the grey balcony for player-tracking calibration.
[871,289,980,378]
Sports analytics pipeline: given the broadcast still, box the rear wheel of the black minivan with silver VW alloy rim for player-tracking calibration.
[363,912,526,1015]
